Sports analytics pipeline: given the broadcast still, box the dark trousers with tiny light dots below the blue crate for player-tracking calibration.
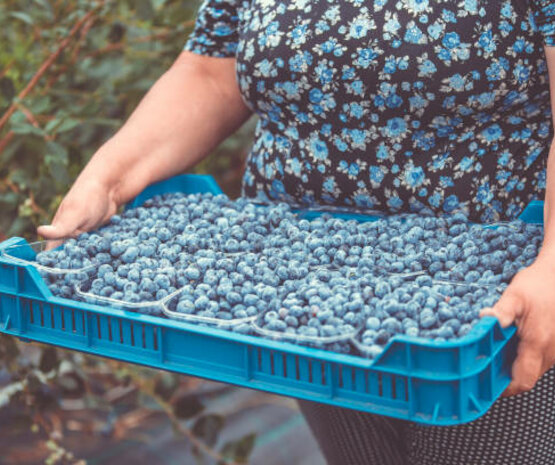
[299,368,555,465]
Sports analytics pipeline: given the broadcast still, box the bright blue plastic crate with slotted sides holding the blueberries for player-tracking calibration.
[0,175,528,425]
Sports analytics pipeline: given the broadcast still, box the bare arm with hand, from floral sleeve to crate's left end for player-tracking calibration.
[38,52,250,239]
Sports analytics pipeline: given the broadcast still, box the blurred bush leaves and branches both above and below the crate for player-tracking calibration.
[0,0,253,464]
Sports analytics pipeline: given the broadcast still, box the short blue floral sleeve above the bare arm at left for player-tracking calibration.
[184,0,240,58]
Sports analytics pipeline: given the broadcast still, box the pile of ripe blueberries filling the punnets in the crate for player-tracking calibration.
[28,190,543,358]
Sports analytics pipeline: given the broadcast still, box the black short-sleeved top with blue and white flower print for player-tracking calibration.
[185,0,555,221]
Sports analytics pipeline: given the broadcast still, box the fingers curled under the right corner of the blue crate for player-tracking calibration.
[503,340,545,397]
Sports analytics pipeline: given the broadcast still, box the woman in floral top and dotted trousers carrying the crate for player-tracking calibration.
[39,0,555,465]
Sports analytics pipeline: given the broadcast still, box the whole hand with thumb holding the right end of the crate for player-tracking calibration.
[480,254,555,397]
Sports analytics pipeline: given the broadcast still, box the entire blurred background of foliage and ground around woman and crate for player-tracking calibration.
[0,0,324,465]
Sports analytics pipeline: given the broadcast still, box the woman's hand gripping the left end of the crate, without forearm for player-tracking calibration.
[37,177,119,240]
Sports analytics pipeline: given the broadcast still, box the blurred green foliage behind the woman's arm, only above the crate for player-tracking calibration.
[0,0,251,239]
